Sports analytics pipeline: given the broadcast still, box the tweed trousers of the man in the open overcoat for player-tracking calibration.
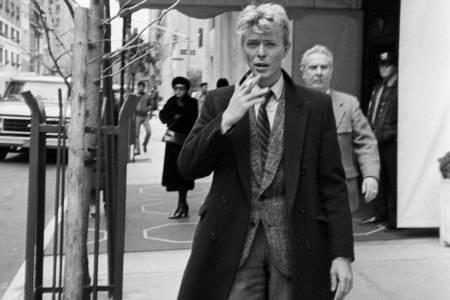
[228,224,292,300]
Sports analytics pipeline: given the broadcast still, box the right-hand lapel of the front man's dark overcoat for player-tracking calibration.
[283,76,309,209]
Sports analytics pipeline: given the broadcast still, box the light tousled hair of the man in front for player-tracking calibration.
[236,3,290,46]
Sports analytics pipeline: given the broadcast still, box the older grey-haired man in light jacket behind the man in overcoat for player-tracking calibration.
[300,45,380,211]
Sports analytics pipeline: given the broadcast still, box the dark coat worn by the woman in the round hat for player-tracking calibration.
[159,95,198,191]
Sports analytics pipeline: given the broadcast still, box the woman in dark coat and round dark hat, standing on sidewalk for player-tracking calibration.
[159,77,198,219]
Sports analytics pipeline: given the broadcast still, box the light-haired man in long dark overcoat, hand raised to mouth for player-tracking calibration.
[178,3,354,300]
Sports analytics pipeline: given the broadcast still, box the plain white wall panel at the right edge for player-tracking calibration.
[398,0,450,227]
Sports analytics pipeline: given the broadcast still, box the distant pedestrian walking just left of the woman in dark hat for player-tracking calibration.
[134,81,153,155]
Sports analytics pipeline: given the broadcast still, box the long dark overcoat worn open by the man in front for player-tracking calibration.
[178,72,354,300]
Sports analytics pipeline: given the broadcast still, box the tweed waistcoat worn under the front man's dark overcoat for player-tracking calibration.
[240,91,292,276]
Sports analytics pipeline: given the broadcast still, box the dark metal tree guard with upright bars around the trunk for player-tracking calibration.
[22,92,137,300]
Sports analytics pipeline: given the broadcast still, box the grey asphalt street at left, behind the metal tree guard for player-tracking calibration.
[0,152,56,299]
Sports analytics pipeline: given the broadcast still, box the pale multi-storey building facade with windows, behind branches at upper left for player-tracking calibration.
[0,0,74,93]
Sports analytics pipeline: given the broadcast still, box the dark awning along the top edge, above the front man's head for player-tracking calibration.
[118,0,362,19]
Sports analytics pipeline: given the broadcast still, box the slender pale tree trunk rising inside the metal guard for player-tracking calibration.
[64,7,89,300]
